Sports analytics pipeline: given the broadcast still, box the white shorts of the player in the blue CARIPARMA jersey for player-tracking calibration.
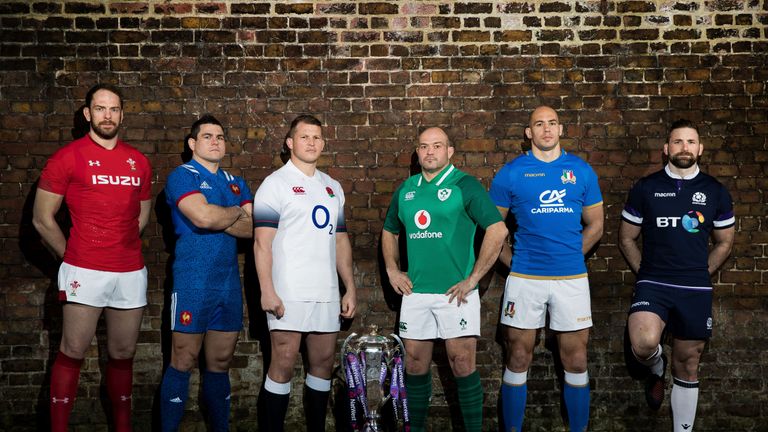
[500,275,592,331]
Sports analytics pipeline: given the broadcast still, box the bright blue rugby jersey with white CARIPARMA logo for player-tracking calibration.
[490,151,603,279]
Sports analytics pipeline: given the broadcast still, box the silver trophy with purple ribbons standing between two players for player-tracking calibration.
[341,325,408,432]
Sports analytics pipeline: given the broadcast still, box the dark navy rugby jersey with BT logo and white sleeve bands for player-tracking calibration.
[621,167,736,288]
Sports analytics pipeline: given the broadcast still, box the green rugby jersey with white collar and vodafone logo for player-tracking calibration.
[384,164,501,294]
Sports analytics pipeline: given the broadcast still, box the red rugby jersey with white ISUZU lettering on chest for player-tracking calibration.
[39,134,152,272]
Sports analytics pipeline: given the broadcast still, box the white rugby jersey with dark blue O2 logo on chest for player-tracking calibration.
[253,161,347,302]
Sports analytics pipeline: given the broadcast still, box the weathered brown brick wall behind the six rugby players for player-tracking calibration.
[0,0,768,431]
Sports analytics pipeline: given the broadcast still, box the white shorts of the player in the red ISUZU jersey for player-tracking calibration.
[58,263,147,309]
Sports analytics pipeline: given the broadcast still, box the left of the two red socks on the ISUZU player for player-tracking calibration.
[50,351,83,432]
